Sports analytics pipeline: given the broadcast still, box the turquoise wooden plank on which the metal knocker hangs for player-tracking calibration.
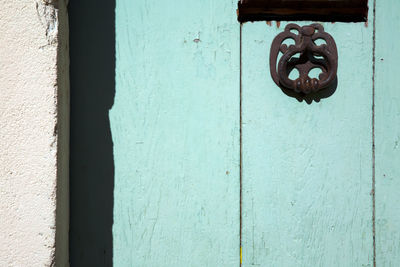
[242,18,373,266]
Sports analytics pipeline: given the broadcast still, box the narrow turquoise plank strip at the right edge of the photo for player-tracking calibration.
[375,0,400,267]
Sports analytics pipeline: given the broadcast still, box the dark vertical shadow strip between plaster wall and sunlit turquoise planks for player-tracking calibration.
[68,0,115,267]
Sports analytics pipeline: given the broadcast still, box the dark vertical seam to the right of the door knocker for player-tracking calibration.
[371,0,376,267]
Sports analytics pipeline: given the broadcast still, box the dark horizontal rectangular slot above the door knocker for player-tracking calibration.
[238,0,368,22]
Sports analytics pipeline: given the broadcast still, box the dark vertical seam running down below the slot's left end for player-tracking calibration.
[239,23,243,267]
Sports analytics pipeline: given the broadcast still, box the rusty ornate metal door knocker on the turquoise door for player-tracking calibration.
[269,23,338,95]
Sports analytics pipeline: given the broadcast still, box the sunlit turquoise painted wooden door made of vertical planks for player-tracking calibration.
[110,0,400,267]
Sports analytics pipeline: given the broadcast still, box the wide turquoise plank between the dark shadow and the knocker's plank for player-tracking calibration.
[110,0,240,266]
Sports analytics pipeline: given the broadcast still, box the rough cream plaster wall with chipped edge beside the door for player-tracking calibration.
[0,0,68,266]
